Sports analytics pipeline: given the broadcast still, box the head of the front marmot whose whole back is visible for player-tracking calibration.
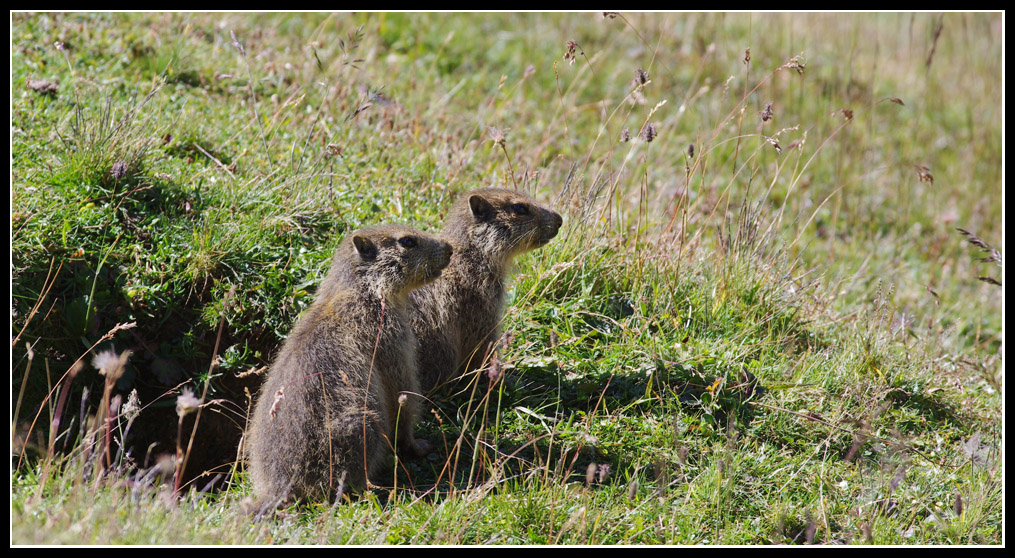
[332,225,452,297]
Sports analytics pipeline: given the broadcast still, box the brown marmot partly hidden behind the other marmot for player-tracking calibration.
[409,189,563,393]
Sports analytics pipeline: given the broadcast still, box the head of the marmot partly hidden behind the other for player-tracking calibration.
[445,189,563,261]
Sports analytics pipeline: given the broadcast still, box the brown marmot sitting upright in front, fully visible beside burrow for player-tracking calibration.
[248,225,452,513]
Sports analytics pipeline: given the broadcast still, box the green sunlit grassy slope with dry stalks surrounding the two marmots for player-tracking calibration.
[11,13,1004,545]
